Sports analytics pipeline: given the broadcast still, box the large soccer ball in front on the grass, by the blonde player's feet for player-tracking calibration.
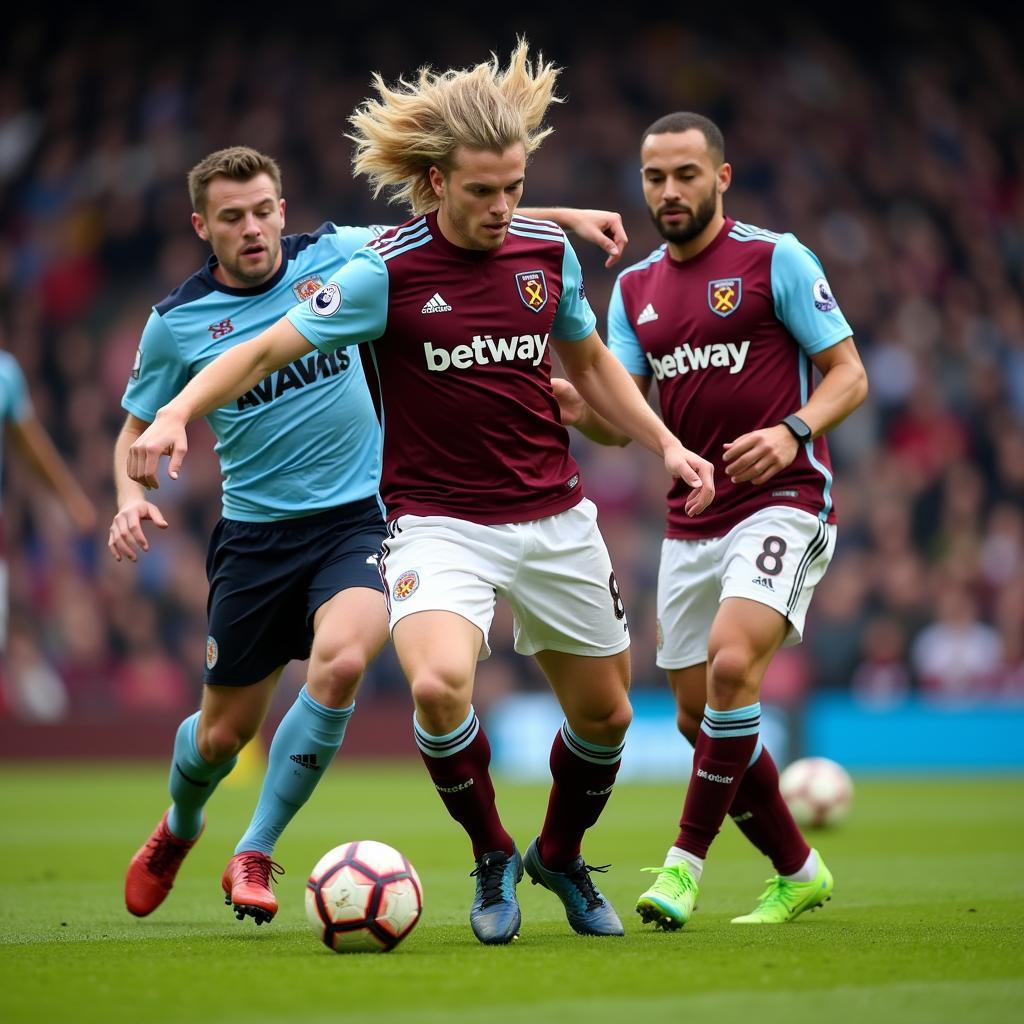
[306,840,423,953]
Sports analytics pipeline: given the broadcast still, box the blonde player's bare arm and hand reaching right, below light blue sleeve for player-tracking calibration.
[552,331,715,516]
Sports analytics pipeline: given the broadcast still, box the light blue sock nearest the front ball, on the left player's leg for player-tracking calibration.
[234,686,355,855]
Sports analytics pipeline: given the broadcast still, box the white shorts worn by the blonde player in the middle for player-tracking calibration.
[380,499,630,660]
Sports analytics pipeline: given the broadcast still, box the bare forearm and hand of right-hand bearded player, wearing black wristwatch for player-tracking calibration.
[723,338,867,486]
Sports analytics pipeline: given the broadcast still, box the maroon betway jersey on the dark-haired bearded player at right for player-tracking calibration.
[608,219,852,539]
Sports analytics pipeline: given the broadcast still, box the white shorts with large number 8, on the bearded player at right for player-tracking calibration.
[657,505,836,669]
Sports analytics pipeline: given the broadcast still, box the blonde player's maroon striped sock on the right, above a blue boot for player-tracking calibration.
[538,722,624,871]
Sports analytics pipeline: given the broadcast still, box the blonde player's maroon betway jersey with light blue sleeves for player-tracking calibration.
[289,213,596,524]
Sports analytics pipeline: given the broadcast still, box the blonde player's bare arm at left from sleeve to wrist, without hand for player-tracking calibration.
[157,319,312,423]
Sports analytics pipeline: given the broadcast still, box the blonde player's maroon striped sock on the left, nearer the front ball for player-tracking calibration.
[413,707,513,860]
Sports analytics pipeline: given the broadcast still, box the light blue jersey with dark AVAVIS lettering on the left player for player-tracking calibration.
[122,223,381,522]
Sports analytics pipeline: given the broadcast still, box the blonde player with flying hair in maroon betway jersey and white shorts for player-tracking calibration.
[128,41,714,944]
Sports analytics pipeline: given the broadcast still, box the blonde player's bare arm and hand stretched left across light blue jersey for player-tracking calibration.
[127,316,313,487]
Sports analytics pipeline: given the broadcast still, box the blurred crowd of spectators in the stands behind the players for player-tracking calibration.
[0,3,1024,720]
